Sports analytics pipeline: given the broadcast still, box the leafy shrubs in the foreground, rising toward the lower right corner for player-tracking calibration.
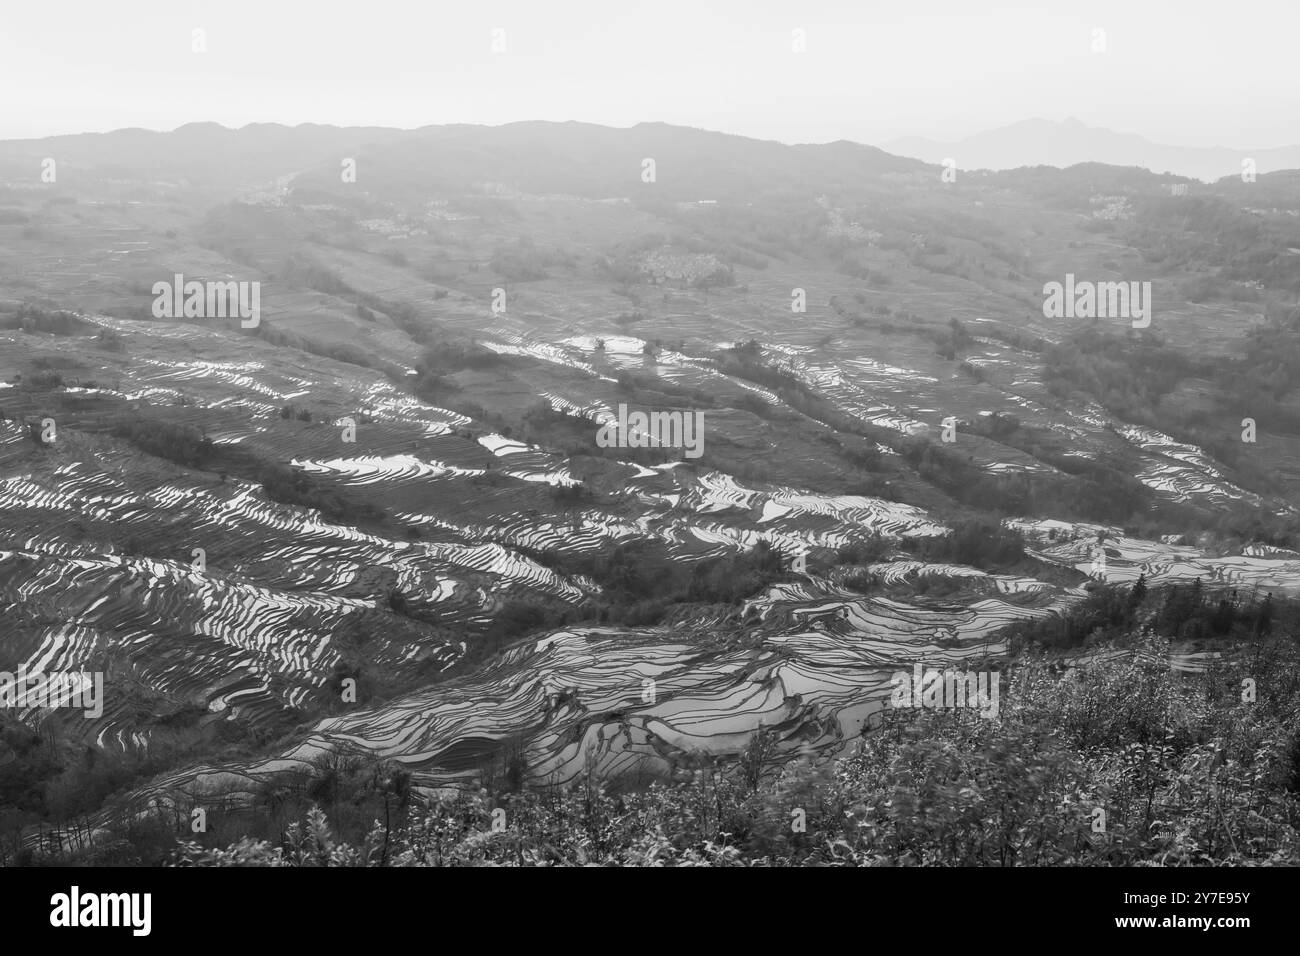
[167,639,1300,866]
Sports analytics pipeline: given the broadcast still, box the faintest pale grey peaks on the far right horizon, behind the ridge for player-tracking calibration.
[880,118,1300,182]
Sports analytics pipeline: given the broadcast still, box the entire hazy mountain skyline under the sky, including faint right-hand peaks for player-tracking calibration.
[0,118,1300,189]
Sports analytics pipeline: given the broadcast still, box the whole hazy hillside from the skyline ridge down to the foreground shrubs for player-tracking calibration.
[0,124,1300,862]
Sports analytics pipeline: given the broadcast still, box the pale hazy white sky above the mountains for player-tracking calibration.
[0,0,1300,148]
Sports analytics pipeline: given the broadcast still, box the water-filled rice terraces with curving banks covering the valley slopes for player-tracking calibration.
[0,121,1300,853]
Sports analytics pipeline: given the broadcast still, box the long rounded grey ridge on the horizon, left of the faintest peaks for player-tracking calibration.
[0,122,926,202]
